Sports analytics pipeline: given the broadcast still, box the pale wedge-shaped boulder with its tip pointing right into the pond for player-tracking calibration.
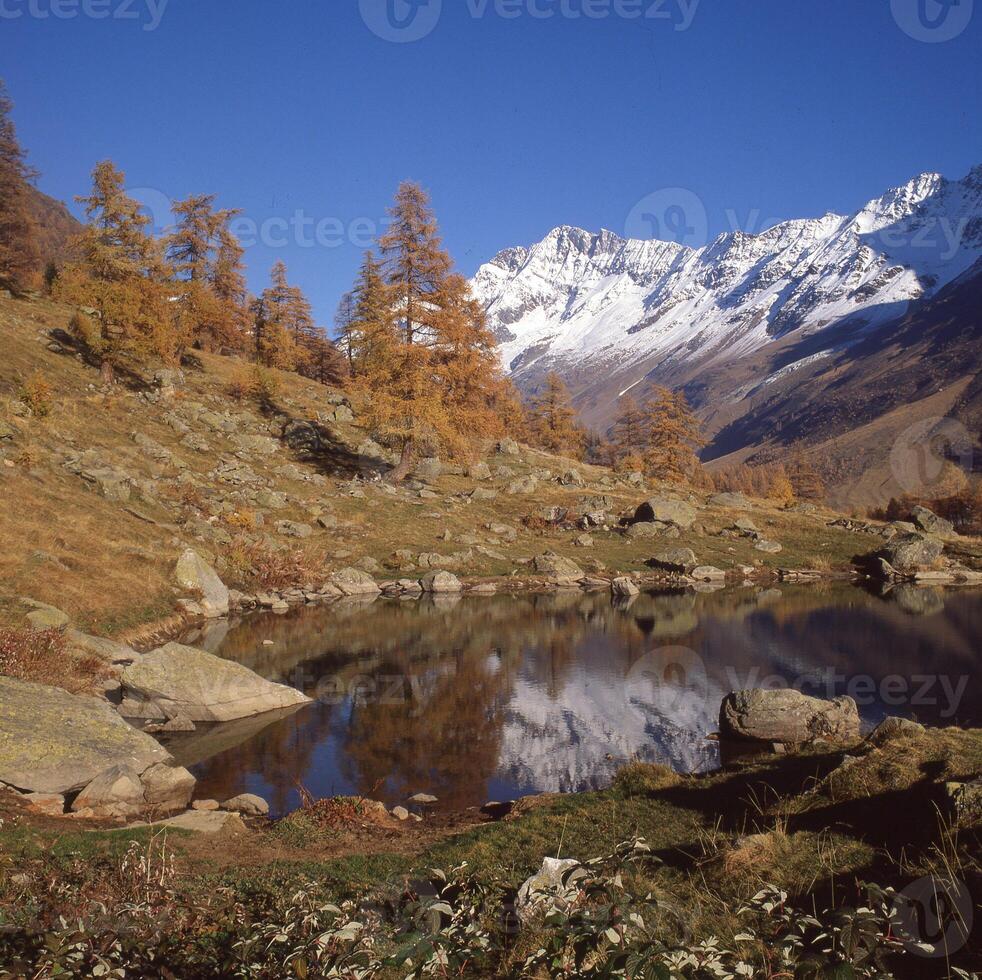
[119,643,310,722]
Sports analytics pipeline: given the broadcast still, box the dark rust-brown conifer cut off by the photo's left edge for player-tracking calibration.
[0,80,41,293]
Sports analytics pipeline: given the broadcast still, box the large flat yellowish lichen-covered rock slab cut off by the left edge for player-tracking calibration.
[0,677,172,793]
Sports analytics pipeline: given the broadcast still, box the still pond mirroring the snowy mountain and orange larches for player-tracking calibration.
[177,585,982,814]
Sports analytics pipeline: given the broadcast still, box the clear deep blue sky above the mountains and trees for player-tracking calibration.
[0,0,982,330]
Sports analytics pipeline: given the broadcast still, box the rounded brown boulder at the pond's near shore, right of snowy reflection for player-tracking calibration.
[719,688,859,744]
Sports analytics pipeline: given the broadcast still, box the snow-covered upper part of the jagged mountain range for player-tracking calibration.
[472,166,982,398]
